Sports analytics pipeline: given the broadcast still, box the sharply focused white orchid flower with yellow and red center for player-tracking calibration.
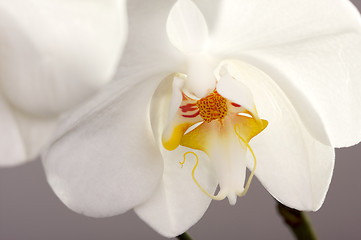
[44,0,361,237]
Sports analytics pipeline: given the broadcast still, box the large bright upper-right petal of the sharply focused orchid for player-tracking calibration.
[202,0,361,147]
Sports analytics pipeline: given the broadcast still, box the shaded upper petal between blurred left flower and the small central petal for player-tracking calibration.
[118,0,181,82]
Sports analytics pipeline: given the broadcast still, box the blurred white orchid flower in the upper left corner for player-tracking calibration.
[0,0,127,166]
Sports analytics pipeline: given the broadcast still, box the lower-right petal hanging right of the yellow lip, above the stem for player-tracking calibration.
[226,62,334,210]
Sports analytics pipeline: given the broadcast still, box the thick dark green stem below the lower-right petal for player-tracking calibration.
[277,203,317,240]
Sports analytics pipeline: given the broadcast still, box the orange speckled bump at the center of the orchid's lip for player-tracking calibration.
[197,91,227,123]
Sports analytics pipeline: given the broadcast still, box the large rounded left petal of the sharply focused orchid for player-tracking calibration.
[44,76,165,217]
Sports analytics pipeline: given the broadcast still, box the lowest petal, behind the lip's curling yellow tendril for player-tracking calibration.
[139,74,217,237]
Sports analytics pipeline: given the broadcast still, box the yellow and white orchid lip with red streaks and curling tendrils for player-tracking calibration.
[162,75,268,204]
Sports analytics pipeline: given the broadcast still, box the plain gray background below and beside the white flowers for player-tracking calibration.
[0,0,361,240]
